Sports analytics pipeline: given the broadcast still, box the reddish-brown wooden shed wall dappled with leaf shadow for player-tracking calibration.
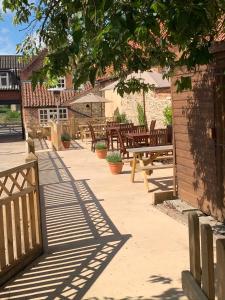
[172,58,225,220]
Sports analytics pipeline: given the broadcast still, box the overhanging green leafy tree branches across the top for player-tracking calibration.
[3,0,225,94]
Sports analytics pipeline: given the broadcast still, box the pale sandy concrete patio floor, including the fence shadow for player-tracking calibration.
[0,142,189,300]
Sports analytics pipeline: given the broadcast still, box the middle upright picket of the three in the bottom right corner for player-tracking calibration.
[201,224,215,300]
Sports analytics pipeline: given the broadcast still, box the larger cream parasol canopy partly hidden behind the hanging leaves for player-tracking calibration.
[102,71,170,91]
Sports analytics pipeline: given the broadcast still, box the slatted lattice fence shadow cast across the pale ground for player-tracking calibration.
[0,151,129,300]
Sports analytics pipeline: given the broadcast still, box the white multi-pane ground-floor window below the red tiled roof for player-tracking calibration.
[39,107,68,125]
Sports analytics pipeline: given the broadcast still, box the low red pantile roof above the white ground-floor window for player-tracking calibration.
[21,82,92,107]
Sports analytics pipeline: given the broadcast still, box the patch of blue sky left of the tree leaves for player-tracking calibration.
[0,0,25,55]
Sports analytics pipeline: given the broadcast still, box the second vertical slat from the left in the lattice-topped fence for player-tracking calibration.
[5,202,14,264]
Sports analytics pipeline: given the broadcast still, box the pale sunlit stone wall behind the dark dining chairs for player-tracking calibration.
[105,89,171,128]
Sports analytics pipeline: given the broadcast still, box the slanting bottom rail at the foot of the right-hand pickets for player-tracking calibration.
[182,271,208,300]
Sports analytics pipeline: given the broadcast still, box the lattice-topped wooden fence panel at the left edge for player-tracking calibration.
[0,161,42,285]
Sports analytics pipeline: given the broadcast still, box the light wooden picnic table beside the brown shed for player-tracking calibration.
[127,145,173,190]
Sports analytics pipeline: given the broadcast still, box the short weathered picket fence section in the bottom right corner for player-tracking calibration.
[182,213,225,300]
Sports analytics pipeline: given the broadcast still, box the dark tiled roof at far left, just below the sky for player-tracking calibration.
[0,55,26,70]
